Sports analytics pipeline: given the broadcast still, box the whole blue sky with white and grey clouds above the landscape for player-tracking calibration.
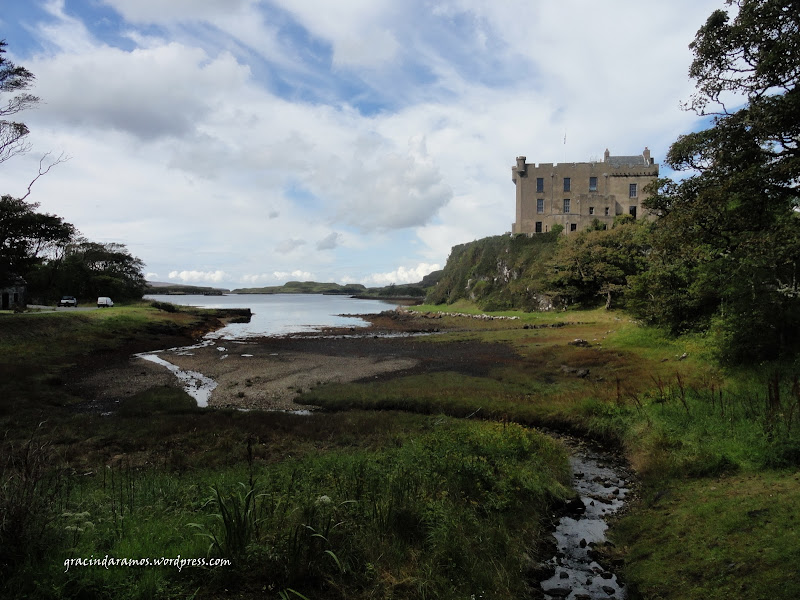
[0,0,723,288]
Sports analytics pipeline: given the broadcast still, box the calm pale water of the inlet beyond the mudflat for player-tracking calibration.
[145,294,398,339]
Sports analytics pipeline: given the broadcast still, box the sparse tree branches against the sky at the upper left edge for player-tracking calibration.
[0,40,39,163]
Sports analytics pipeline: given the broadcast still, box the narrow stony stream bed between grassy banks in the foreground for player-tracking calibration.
[541,436,631,600]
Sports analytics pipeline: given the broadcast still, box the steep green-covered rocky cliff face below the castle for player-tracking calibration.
[426,233,558,310]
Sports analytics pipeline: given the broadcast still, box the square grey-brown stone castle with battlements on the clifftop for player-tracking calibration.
[511,148,658,234]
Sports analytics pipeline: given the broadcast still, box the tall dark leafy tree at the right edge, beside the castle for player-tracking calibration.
[634,0,800,361]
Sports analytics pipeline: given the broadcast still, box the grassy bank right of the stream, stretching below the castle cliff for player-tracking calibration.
[305,304,800,599]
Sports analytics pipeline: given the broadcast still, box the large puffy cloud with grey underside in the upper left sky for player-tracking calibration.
[31,43,249,140]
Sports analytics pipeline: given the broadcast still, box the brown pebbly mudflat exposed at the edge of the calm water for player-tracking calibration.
[73,311,519,412]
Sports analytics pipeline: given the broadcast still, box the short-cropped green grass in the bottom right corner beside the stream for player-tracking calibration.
[613,470,800,600]
